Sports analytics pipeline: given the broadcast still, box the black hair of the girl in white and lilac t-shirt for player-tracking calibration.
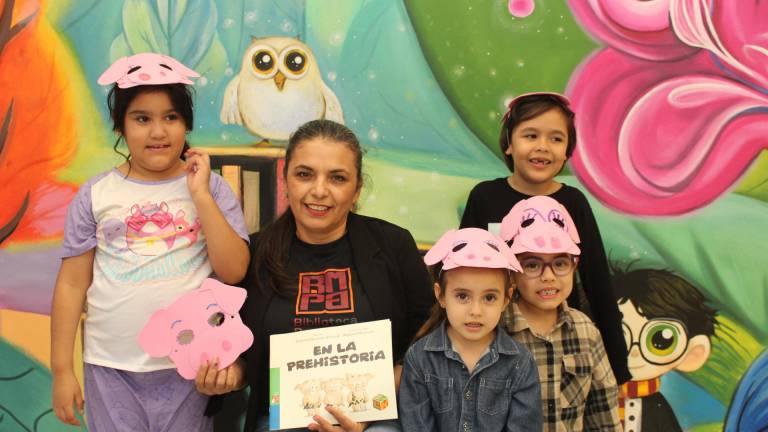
[107,83,195,170]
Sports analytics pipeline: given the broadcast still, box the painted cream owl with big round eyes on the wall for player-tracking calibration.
[220,37,344,141]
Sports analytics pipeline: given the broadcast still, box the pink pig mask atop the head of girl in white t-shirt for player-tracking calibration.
[97,53,200,88]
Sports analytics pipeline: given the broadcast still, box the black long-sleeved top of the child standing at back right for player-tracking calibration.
[461,177,630,384]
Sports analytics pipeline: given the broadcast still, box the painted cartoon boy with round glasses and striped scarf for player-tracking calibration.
[613,268,717,432]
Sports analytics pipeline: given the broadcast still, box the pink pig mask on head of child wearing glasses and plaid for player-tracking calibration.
[501,196,581,255]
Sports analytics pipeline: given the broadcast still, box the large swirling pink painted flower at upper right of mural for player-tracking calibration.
[568,0,768,216]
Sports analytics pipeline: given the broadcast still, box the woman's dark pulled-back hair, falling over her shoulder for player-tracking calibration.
[251,120,364,295]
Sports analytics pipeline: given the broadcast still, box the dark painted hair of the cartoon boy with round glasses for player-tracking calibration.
[611,264,718,337]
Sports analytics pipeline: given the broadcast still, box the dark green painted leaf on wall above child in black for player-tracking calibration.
[405,0,597,156]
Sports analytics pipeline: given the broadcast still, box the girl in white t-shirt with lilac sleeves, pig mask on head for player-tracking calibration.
[51,53,249,431]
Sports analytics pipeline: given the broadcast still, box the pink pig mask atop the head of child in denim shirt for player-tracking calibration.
[424,228,520,272]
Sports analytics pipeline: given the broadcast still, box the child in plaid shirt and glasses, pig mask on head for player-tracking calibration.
[501,196,622,432]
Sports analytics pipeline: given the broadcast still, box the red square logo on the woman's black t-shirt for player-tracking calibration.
[296,268,355,315]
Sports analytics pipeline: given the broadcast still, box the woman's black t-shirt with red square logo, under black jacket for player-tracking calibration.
[264,235,374,335]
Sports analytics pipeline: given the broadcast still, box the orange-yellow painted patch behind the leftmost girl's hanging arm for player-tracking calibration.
[0,309,83,386]
